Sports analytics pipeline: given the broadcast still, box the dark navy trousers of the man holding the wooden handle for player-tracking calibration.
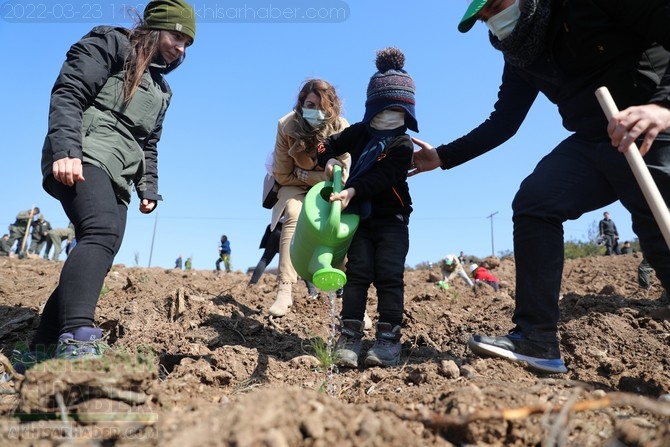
[512,136,670,341]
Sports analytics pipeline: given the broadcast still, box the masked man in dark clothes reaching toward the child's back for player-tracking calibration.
[410,0,670,373]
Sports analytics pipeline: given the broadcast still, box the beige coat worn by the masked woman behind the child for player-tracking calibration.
[271,110,351,230]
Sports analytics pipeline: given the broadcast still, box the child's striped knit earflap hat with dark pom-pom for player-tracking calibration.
[363,47,419,132]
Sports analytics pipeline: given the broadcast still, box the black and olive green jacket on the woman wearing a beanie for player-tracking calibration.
[42,26,181,205]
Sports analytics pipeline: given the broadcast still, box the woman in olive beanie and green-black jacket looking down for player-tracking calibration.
[13,0,195,369]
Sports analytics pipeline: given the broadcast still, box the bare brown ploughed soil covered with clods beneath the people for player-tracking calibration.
[0,254,670,447]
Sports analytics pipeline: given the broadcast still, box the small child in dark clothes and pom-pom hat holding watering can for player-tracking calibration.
[318,48,418,368]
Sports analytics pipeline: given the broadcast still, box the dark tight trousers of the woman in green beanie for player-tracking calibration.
[32,165,128,347]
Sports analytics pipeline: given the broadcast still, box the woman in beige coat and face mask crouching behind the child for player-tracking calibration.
[268,79,350,317]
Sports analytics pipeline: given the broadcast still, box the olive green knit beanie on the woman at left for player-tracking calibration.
[144,0,195,40]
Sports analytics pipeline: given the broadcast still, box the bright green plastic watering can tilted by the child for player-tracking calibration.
[290,165,359,291]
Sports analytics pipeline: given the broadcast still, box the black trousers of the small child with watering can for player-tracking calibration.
[341,216,409,327]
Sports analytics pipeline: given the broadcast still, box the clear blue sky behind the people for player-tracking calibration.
[0,0,635,271]
